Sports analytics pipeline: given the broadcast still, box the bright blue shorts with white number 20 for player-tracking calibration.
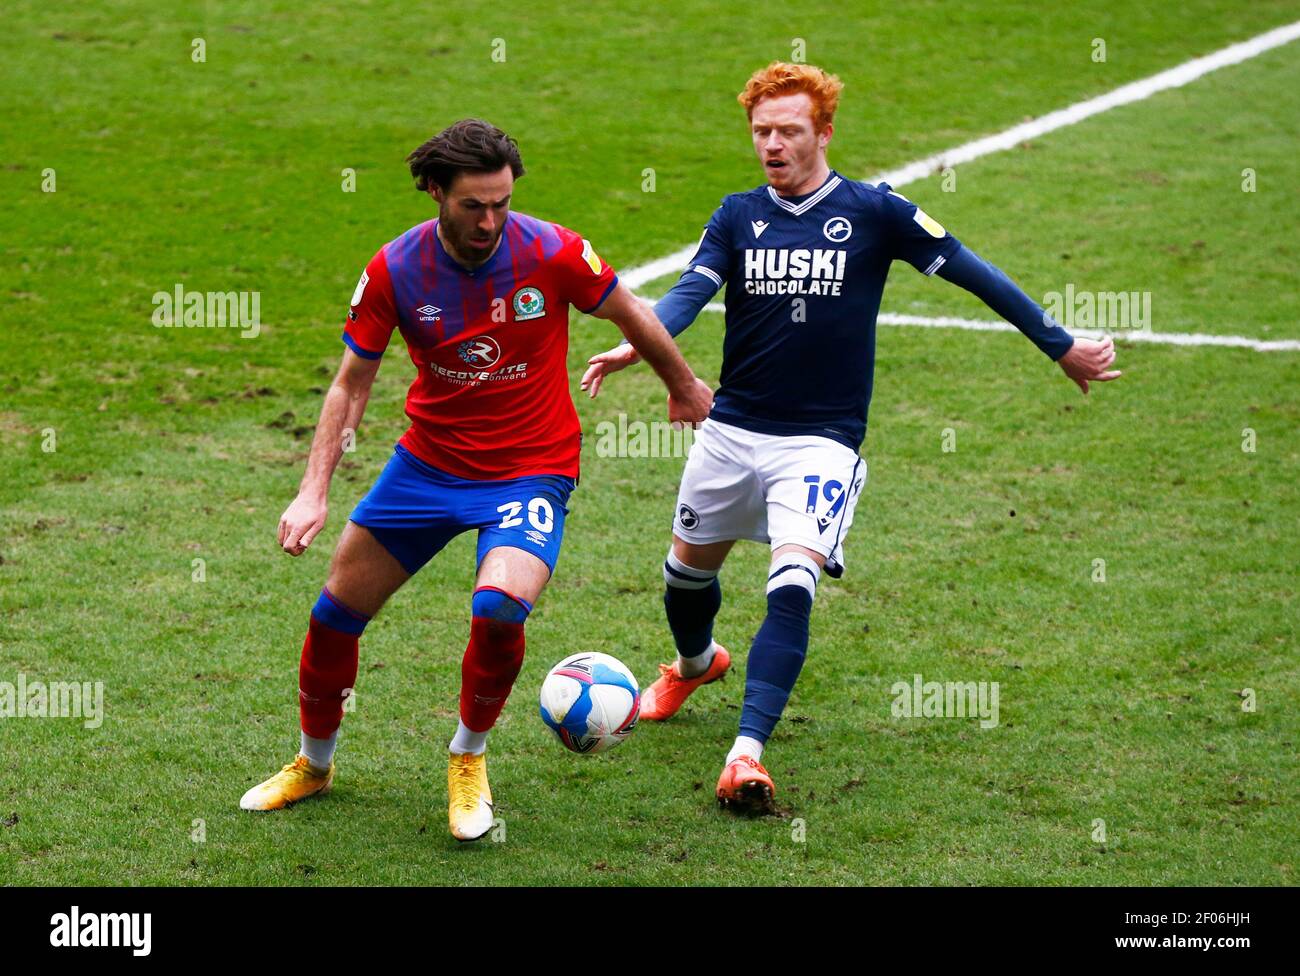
[350,444,575,576]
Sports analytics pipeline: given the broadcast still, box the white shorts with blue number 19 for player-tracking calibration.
[672,420,867,576]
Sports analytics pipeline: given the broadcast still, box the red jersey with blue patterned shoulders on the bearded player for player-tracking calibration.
[343,213,618,481]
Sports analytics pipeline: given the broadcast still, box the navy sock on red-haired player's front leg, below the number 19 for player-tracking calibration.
[740,571,813,742]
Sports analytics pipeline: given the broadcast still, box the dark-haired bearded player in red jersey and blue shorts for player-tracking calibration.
[239,120,712,841]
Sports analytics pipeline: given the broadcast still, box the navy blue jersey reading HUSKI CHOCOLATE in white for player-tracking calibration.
[683,170,961,450]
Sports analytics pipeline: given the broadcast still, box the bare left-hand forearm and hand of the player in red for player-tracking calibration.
[277,348,380,556]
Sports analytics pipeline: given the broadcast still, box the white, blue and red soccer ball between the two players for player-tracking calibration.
[541,652,641,755]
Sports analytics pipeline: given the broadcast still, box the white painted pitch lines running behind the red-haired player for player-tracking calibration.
[619,21,1300,352]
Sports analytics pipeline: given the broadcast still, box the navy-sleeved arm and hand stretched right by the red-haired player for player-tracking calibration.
[937,244,1121,392]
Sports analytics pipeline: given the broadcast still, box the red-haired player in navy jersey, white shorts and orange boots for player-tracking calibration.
[582,62,1119,810]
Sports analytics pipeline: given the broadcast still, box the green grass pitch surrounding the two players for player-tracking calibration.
[0,0,1300,885]
